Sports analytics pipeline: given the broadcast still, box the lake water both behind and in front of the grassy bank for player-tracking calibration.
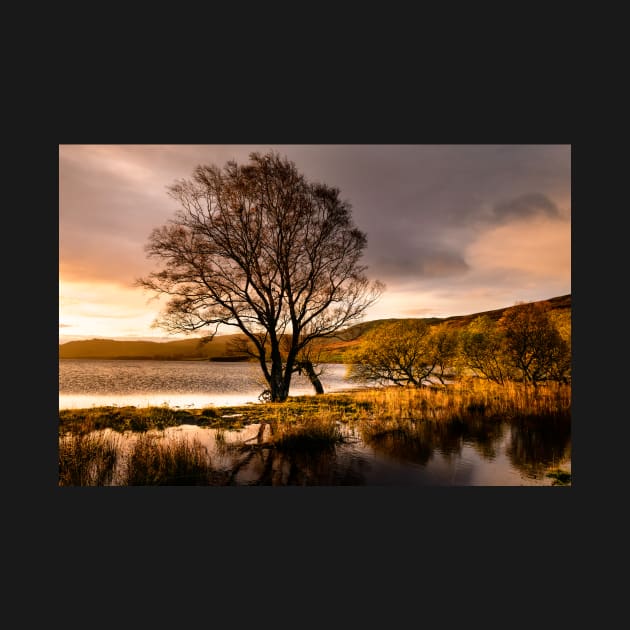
[59,359,571,486]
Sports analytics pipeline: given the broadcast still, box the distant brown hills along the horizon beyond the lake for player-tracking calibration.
[59,294,571,363]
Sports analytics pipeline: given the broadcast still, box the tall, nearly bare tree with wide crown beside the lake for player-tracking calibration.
[138,152,383,402]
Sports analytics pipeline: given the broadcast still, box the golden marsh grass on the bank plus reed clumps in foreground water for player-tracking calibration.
[59,380,571,485]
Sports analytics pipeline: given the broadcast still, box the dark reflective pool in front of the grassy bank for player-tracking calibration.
[63,418,571,486]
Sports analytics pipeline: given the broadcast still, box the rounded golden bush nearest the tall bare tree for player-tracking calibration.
[348,319,457,387]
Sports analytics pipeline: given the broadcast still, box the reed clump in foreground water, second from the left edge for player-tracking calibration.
[122,434,214,486]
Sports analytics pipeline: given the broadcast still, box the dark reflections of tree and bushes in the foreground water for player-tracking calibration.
[202,417,571,486]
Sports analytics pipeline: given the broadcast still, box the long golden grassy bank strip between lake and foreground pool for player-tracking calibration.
[59,380,571,435]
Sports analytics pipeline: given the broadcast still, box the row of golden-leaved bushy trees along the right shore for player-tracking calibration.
[348,301,571,387]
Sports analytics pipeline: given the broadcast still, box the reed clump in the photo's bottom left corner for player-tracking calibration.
[59,433,120,486]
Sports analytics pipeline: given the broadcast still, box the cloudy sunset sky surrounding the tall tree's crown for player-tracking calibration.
[59,144,571,343]
